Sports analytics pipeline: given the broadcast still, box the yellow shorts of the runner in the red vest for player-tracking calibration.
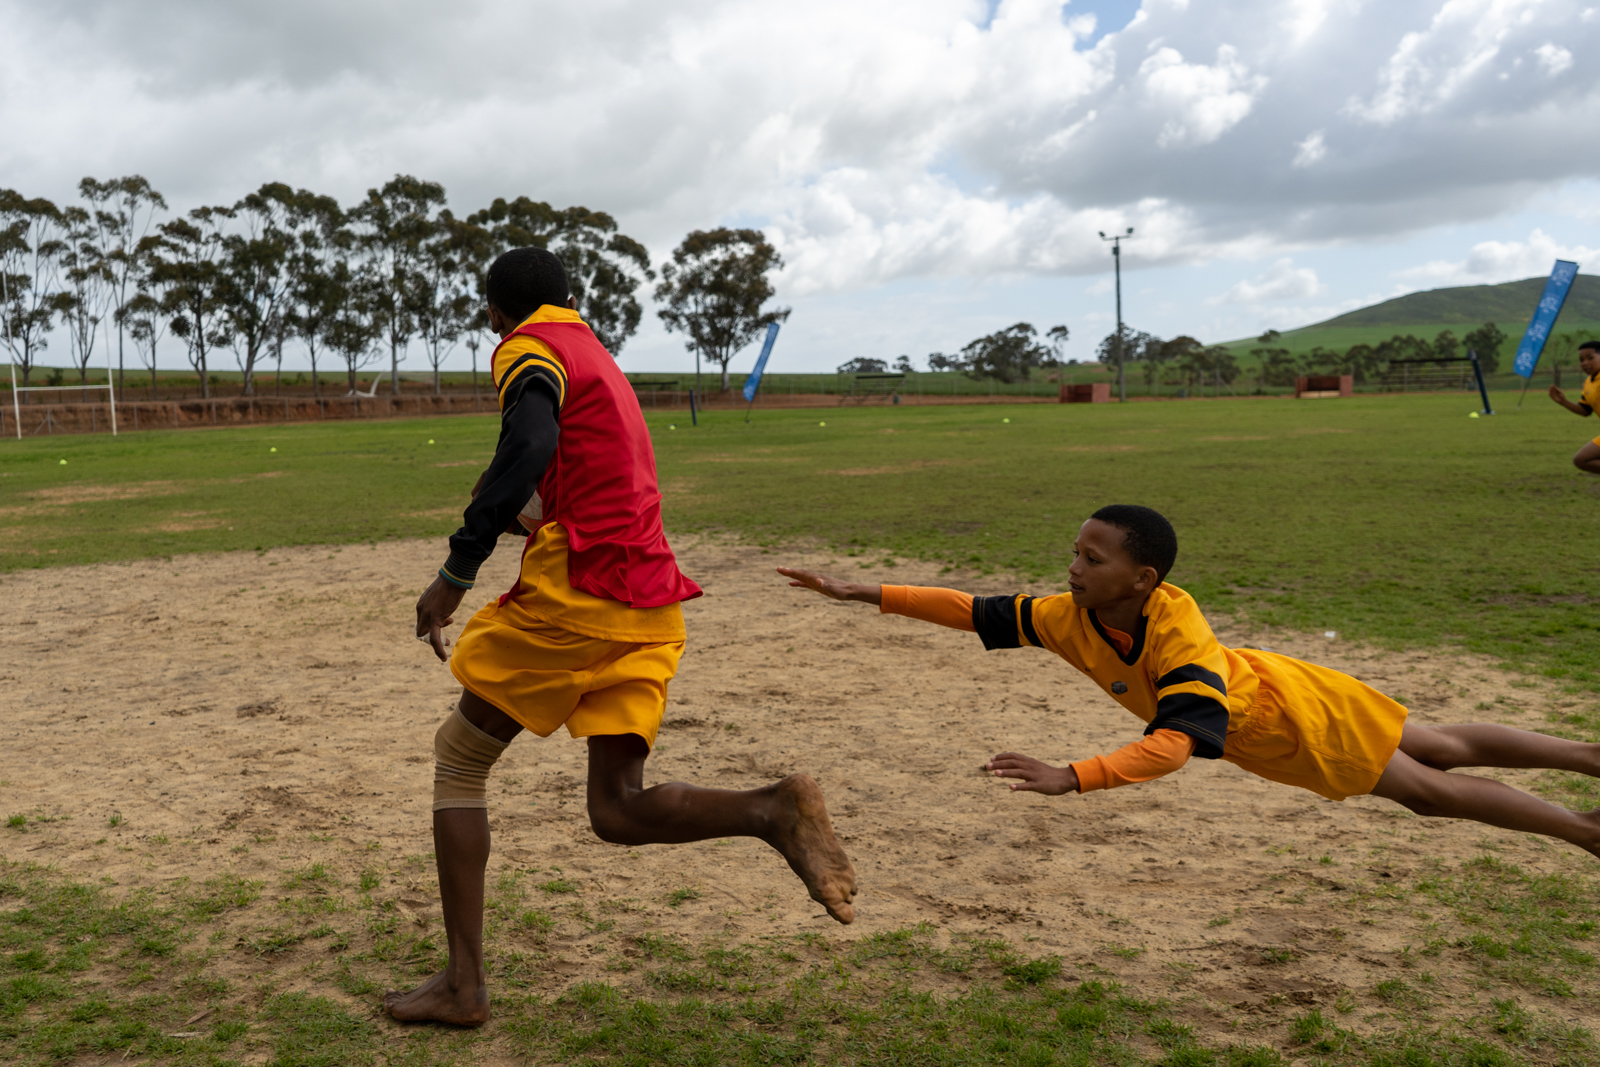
[450,601,683,747]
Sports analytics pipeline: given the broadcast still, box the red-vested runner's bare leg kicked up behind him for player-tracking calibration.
[589,734,856,923]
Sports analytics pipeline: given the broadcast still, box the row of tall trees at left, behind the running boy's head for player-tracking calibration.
[0,174,789,397]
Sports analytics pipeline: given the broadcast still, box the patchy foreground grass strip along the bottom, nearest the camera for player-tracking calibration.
[0,857,1600,1067]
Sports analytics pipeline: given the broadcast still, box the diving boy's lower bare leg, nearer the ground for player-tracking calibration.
[1373,751,1600,856]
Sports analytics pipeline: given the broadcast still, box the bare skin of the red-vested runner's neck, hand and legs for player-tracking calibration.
[384,302,856,1027]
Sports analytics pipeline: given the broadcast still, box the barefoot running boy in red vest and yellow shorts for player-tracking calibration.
[393,248,856,1027]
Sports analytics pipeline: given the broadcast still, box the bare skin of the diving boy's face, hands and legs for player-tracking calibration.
[778,518,1600,856]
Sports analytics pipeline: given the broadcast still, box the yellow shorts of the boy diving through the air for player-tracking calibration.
[1222,648,1406,800]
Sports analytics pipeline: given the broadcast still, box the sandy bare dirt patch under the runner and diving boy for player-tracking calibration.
[0,539,1600,1030]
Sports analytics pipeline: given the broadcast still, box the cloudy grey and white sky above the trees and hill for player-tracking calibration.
[0,0,1600,371]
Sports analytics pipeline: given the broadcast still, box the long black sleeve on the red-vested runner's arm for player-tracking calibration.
[438,374,560,589]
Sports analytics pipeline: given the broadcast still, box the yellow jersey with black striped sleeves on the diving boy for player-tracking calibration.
[973,582,1259,760]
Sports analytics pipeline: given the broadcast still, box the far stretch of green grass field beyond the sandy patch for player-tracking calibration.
[0,395,1600,688]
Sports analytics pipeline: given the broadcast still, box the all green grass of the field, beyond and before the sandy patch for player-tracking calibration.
[9,395,1600,1067]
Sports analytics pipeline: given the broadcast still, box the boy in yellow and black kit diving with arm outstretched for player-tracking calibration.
[778,504,1600,856]
